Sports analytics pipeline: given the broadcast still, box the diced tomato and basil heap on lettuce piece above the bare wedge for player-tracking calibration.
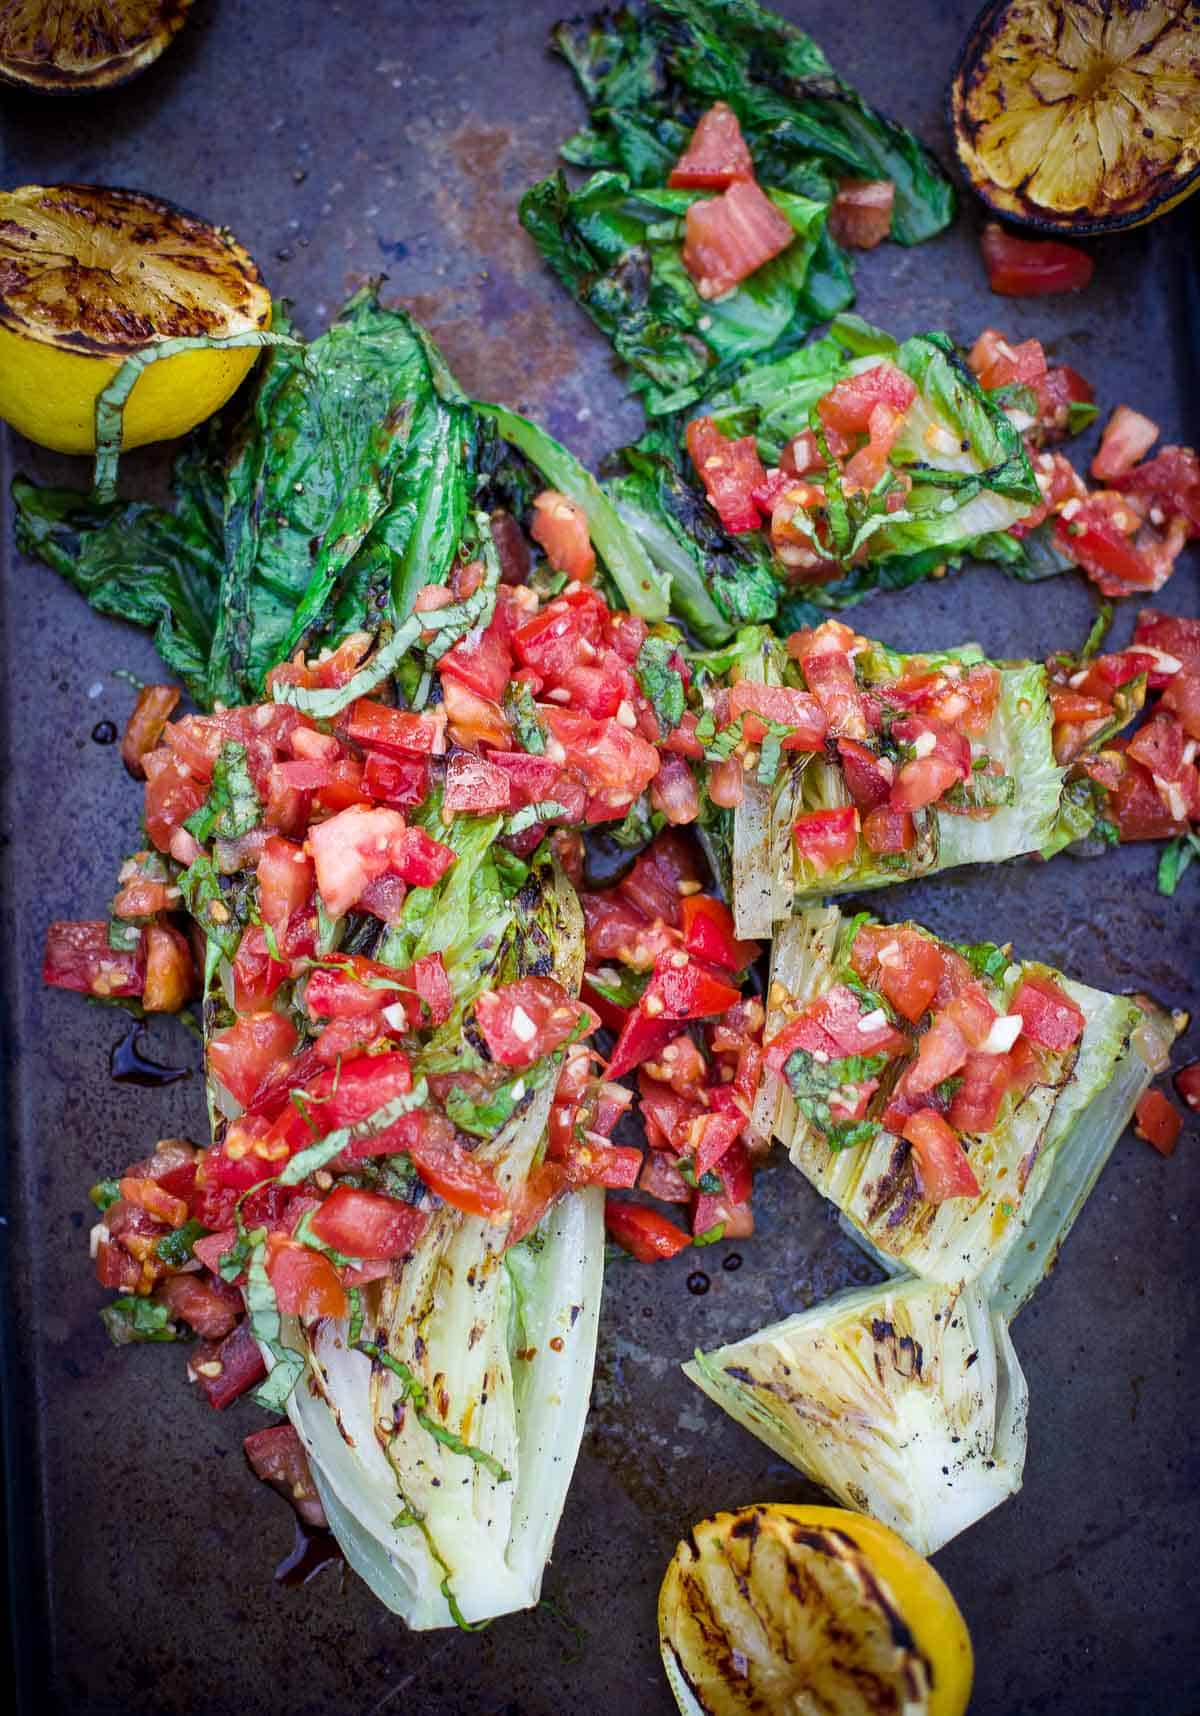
[764,915,1085,1203]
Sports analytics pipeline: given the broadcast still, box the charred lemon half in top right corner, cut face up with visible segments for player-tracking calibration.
[949,0,1200,235]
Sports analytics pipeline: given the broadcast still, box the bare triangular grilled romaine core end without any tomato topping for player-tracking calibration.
[683,1277,1028,1555]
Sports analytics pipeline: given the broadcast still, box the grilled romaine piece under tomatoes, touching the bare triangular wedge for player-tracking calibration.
[754,906,1174,1290]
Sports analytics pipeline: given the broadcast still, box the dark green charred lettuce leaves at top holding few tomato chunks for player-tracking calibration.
[522,0,955,414]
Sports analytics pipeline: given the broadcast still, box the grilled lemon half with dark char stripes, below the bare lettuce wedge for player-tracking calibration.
[658,1503,972,1716]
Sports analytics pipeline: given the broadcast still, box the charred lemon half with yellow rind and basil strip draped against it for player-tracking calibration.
[0,185,271,453]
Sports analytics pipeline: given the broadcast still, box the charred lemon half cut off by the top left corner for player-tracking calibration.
[0,0,192,94]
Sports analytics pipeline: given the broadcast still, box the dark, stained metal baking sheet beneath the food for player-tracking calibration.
[0,0,1200,1716]
